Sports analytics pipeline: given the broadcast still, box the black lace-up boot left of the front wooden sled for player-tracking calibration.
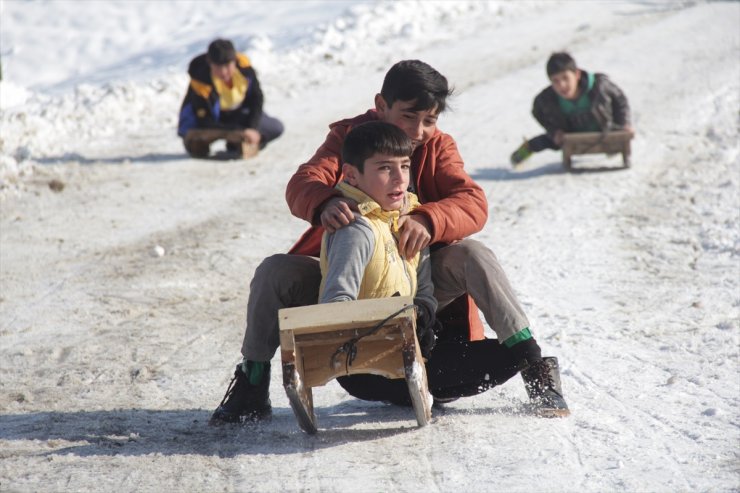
[209,362,272,425]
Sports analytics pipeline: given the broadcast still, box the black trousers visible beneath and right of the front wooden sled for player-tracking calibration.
[337,339,520,406]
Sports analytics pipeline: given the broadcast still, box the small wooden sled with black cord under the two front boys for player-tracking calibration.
[278,297,432,434]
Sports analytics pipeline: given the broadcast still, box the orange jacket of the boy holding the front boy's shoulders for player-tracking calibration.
[285,110,488,340]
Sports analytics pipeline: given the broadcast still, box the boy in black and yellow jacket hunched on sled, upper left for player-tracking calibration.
[177,39,283,158]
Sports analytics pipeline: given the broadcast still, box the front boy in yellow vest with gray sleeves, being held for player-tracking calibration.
[319,121,437,358]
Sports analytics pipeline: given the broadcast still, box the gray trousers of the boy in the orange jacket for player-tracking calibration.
[242,239,529,361]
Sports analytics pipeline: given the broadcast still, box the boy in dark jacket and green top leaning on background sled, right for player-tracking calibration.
[511,52,633,166]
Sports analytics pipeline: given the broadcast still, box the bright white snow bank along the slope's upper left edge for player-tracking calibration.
[0,0,538,198]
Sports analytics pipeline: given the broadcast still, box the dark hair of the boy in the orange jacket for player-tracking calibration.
[380,60,453,114]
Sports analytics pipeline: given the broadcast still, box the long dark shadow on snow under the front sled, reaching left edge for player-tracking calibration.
[0,403,428,457]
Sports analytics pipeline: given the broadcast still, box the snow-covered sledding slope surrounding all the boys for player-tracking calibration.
[0,0,740,492]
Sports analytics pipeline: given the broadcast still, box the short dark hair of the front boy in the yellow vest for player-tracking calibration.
[342,121,414,173]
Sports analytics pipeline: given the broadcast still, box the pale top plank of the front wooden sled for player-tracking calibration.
[278,296,414,334]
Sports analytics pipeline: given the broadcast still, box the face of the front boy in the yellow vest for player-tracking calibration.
[343,154,411,211]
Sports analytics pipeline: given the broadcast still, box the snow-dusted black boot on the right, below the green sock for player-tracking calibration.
[522,356,570,418]
